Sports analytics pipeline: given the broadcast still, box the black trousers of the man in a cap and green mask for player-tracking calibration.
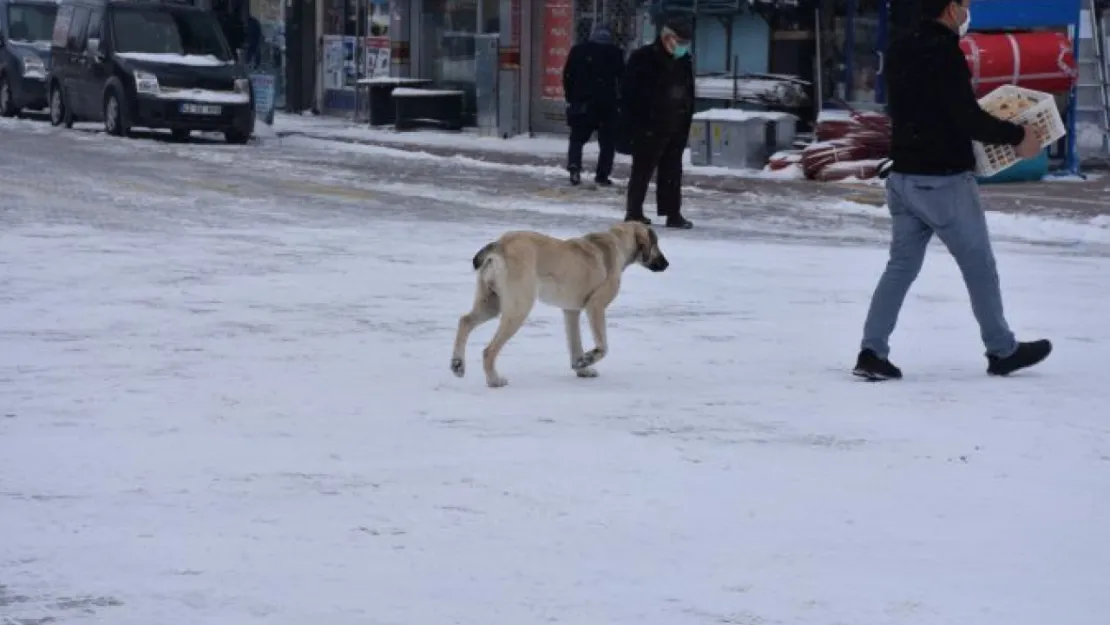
[625,132,687,221]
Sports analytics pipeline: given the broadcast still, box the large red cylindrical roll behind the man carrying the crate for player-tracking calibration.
[960,32,1079,98]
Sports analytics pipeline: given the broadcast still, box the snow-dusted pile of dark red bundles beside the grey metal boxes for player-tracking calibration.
[768,111,890,181]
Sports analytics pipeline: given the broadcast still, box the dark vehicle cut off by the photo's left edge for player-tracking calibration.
[0,0,58,118]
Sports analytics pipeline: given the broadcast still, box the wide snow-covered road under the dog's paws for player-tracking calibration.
[0,120,1110,625]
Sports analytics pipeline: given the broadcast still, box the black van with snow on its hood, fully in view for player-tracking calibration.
[47,0,254,143]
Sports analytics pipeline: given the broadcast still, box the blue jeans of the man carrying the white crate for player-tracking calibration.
[861,173,1018,357]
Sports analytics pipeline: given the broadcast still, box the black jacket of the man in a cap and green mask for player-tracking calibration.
[617,40,694,153]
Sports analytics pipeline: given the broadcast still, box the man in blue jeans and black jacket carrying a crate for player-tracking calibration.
[854,0,1052,380]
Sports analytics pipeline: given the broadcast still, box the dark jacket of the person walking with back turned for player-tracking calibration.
[563,41,624,123]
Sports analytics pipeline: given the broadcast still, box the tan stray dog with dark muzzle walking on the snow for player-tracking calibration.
[451,222,670,387]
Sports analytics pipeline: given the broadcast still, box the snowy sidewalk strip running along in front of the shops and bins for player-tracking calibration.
[266,113,1110,220]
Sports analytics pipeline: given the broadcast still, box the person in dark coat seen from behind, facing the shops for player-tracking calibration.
[563,26,624,187]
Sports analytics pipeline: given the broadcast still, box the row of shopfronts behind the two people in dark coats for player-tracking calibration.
[279,0,890,137]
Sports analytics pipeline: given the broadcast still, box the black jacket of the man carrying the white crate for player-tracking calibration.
[887,20,1025,175]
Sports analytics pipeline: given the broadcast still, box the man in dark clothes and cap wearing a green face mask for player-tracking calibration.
[620,18,694,229]
